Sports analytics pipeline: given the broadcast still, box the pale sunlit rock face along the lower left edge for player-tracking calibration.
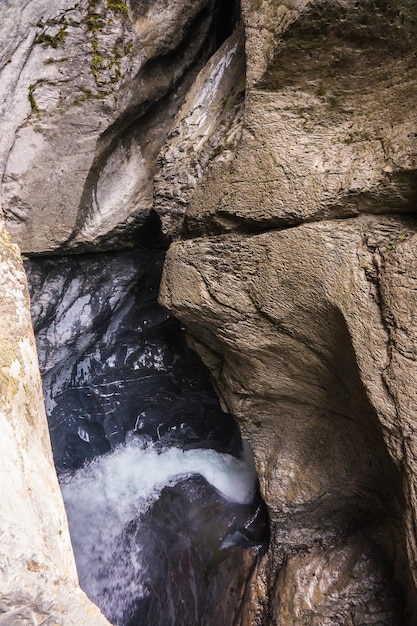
[0,230,109,626]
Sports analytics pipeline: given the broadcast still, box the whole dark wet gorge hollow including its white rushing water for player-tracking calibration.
[26,249,269,626]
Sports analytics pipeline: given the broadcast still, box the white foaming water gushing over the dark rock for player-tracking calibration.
[61,437,256,624]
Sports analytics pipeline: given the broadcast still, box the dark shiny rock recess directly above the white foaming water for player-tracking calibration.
[26,214,244,470]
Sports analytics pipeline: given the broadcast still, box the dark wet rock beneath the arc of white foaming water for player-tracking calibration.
[132,478,269,626]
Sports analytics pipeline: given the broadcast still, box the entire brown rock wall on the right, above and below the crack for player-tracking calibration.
[160,1,417,626]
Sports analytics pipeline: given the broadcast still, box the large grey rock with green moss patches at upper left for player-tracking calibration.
[0,0,229,252]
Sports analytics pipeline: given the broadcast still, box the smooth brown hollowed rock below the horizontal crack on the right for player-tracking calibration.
[161,217,416,625]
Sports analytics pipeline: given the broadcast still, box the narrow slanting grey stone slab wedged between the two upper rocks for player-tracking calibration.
[154,28,245,237]
